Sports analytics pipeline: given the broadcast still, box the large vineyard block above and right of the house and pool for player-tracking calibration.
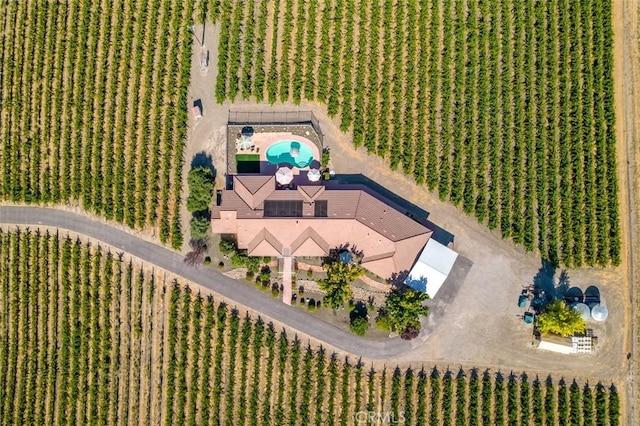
[210,0,620,266]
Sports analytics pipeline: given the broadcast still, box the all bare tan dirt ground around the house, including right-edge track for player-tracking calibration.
[183,10,640,406]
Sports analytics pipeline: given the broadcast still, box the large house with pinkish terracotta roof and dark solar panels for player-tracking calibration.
[211,175,432,279]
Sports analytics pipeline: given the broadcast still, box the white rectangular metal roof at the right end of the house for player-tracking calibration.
[404,239,458,298]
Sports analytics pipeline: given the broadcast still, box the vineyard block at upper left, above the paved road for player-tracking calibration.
[0,0,194,247]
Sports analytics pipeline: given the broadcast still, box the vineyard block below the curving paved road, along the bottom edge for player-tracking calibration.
[0,230,620,425]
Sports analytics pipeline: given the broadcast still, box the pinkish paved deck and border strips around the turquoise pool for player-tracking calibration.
[227,124,322,174]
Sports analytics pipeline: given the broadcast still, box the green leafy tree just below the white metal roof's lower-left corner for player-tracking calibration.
[377,287,429,340]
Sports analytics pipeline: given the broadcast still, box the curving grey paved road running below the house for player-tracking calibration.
[0,206,412,360]
